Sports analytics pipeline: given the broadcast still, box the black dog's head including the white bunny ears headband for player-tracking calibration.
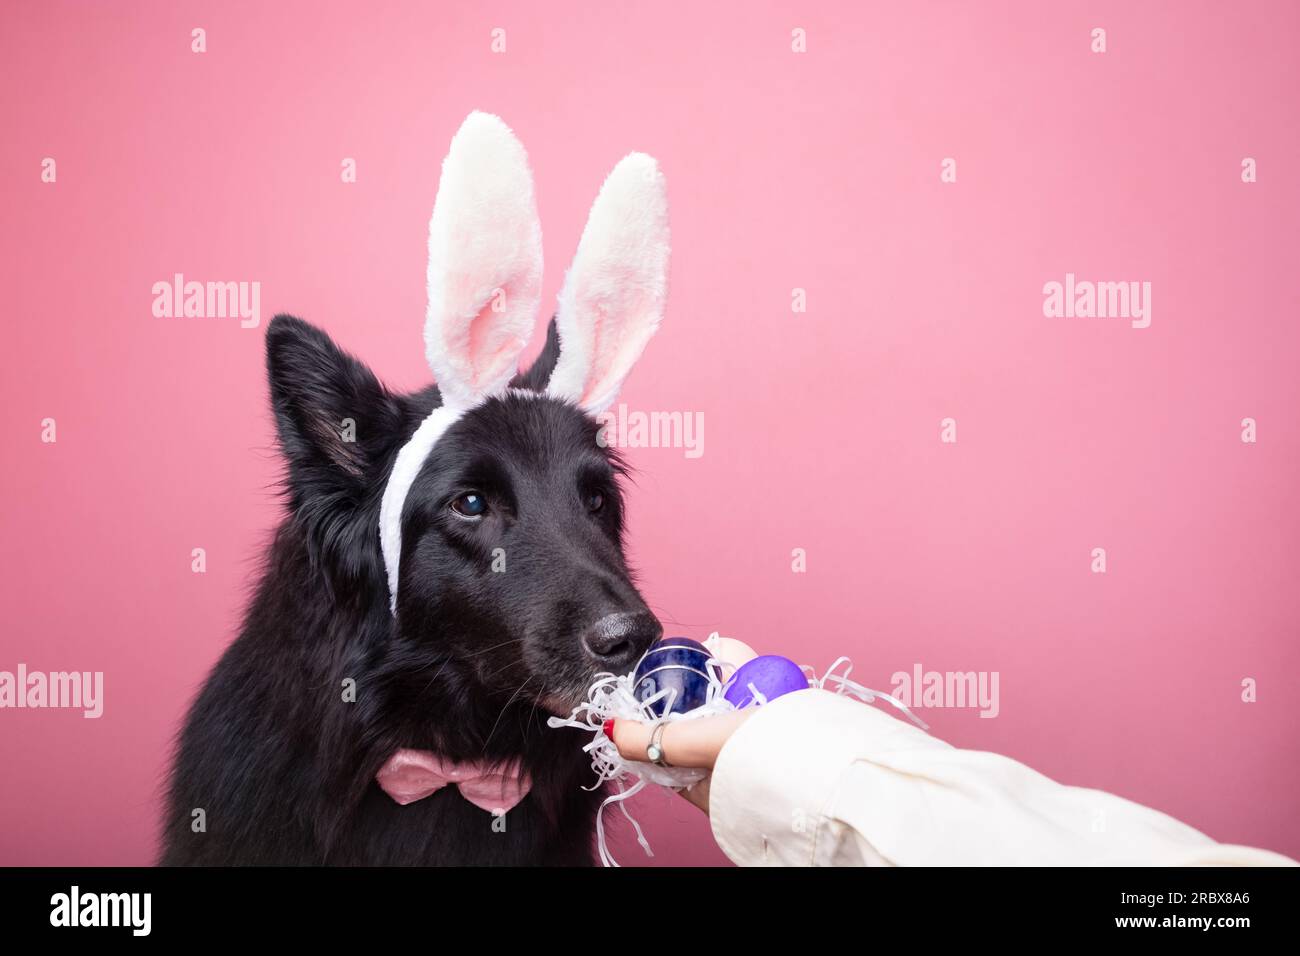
[267,113,668,713]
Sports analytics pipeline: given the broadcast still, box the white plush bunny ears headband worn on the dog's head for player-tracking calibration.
[380,112,668,613]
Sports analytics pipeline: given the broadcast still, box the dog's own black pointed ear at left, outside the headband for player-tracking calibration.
[267,315,403,509]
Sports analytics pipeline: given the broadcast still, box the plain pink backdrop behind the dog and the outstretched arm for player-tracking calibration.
[0,0,1300,864]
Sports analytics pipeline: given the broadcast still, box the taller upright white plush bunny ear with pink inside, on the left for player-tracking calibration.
[424,112,542,408]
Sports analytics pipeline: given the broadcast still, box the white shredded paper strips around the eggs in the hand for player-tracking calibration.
[547,631,930,866]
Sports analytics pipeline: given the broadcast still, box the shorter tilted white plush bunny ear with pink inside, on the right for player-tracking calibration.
[546,152,668,415]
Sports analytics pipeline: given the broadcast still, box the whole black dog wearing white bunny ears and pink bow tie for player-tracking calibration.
[163,113,668,864]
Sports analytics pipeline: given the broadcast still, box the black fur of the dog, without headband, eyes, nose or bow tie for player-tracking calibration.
[161,316,660,865]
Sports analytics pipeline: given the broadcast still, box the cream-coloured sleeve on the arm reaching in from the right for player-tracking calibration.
[709,689,1295,866]
